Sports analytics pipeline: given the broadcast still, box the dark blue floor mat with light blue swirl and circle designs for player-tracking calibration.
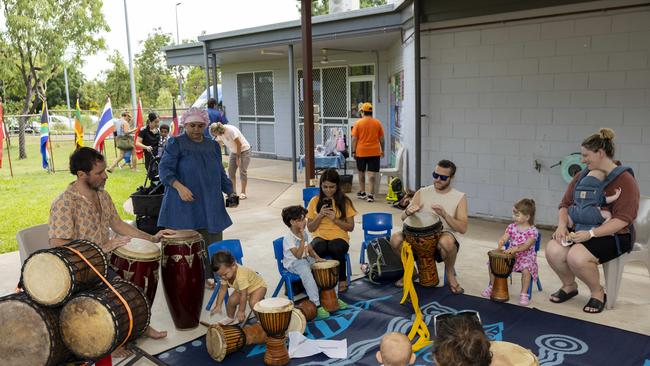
[156,279,650,366]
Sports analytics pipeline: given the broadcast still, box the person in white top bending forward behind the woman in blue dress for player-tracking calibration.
[210,122,251,200]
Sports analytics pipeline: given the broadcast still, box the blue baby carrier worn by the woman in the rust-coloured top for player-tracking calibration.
[569,166,634,231]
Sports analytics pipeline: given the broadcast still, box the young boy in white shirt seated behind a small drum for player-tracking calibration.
[282,205,330,319]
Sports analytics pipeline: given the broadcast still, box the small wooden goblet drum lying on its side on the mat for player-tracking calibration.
[206,323,266,362]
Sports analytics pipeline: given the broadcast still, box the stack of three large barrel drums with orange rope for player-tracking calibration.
[0,240,151,365]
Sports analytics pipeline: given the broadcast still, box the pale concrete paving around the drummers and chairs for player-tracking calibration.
[0,159,650,364]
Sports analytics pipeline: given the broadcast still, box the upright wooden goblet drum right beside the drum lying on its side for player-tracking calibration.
[253,297,293,366]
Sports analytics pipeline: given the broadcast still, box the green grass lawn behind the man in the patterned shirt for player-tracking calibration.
[0,136,145,253]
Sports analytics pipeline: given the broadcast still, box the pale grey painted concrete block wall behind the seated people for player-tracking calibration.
[420,8,650,224]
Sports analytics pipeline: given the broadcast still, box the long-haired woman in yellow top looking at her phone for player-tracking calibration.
[307,169,357,292]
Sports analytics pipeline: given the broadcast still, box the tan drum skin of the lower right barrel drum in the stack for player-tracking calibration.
[60,295,114,359]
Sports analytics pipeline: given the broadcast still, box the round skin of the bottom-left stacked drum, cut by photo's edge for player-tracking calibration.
[0,295,56,366]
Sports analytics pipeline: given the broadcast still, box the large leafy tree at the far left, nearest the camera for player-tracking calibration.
[0,0,109,159]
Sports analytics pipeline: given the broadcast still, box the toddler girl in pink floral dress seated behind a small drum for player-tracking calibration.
[481,198,538,306]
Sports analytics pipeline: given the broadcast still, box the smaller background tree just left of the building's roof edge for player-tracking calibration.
[135,28,178,108]
